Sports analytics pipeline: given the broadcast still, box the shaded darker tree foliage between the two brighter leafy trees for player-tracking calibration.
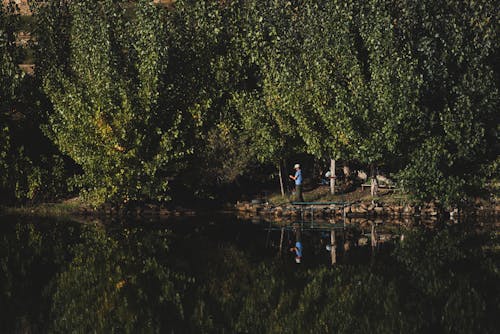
[166,1,268,196]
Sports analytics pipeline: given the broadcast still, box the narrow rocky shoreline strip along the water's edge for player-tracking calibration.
[0,193,500,222]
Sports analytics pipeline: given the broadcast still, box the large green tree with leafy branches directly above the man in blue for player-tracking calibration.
[238,1,421,196]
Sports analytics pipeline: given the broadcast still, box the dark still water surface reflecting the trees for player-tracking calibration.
[0,214,500,333]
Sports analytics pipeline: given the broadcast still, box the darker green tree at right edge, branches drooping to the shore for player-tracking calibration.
[394,0,499,205]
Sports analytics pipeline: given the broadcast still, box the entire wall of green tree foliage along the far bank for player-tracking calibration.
[0,0,500,206]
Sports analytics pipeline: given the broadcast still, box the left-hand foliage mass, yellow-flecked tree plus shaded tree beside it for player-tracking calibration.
[35,1,270,204]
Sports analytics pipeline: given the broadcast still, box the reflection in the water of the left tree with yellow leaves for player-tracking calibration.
[52,229,190,333]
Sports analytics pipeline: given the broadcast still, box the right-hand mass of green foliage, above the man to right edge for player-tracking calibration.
[236,0,499,205]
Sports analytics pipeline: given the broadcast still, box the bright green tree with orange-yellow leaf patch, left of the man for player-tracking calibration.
[38,0,189,204]
